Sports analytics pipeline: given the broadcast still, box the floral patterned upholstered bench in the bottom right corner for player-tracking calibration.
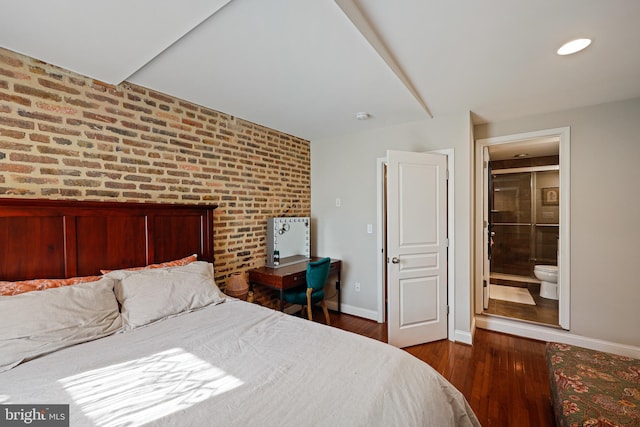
[546,343,640,427]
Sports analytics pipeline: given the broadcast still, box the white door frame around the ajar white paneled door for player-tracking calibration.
[376,148,455,341]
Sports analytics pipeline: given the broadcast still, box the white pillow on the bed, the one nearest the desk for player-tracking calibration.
[106,261,224,330]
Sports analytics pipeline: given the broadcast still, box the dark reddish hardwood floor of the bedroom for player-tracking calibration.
[314,311,555,427]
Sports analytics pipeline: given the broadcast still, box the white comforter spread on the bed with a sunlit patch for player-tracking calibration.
[0,299,479,427]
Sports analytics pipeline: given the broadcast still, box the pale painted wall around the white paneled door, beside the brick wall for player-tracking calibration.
[311,113,473,335]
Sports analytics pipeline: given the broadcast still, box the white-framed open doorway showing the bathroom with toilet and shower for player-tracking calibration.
[476,129,569,329]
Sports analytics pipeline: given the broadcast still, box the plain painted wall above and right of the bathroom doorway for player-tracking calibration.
[474,98,640,346]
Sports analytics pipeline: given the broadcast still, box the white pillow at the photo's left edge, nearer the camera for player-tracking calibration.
[0,278,122,372]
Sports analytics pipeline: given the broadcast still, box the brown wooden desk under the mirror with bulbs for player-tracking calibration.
[249,257,342,312]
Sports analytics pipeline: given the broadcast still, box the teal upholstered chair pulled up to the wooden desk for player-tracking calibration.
[283,258,331,325]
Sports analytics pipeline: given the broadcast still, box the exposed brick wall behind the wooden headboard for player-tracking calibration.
[0,48,311,305]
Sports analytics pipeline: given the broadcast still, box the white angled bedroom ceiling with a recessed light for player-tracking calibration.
[0,0,640,140]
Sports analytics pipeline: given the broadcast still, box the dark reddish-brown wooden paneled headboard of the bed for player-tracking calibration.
[0,198,217,281]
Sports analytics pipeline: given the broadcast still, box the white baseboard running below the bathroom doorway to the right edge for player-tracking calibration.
[475,315,640,359]
